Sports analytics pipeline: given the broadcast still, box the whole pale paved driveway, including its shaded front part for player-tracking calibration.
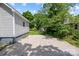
[0,35,79,56]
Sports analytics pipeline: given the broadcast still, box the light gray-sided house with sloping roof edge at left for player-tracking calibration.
[0,3,29,44]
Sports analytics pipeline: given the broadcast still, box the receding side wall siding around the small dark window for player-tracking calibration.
[15,13,29,37]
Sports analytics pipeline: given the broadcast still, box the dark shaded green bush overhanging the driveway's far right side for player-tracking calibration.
[43,23,72,39]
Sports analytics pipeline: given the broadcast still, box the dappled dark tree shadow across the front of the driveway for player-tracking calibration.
[0,43,72,56]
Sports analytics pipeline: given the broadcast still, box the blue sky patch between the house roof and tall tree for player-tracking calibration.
[10,3,43,14]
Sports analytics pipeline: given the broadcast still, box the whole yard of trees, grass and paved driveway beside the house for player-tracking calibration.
[0,3,79,56]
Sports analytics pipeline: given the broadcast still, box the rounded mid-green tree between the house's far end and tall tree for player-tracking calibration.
[34,13,48,30]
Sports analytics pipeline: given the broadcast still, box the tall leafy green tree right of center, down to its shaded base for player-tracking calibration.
[39,3,73,38]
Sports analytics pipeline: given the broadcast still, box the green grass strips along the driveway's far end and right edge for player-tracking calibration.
[29,29,79,48]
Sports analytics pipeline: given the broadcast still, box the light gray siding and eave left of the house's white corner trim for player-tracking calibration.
[0,4,13,37]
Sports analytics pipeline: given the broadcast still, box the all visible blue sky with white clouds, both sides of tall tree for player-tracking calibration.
[10,3,79,15]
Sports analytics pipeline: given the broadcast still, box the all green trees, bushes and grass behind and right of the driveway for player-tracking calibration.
[23,3,79,47]
